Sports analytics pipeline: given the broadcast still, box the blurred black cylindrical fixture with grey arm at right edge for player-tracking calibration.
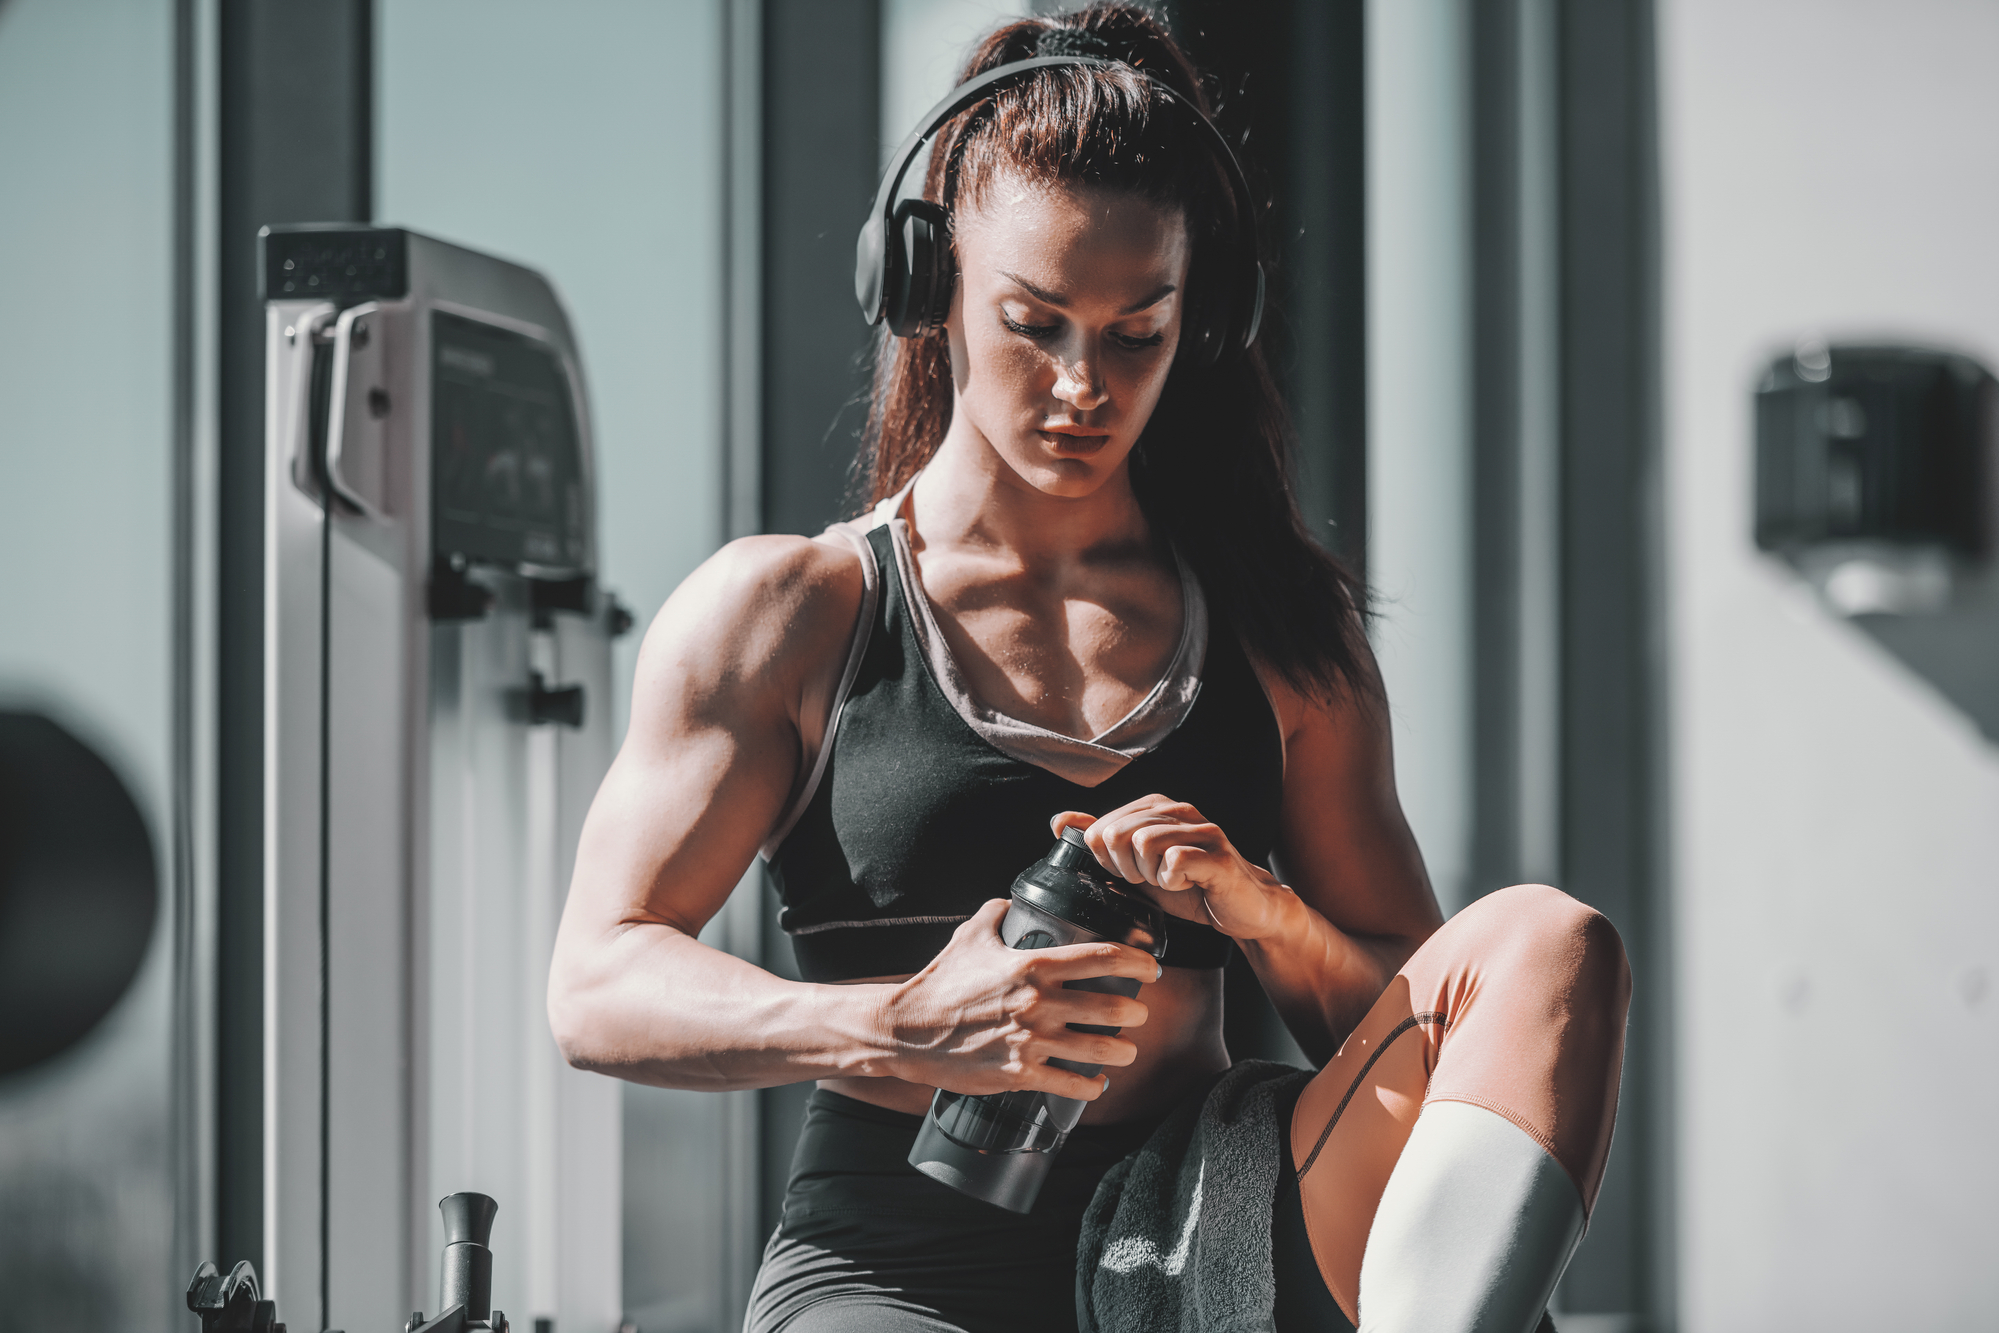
[1755,342,1999,737]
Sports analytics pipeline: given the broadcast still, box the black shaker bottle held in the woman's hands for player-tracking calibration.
[910,829,1165,1213]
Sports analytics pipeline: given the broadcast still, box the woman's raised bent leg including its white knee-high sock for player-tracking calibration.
[1289,885,1631,1333]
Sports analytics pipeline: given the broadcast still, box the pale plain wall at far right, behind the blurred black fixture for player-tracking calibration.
[1659,0,1999,1333]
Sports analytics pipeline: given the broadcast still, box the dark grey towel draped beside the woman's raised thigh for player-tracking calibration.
[1075,1059,1311,1333]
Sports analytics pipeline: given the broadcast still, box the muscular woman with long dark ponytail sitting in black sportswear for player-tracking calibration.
[550,6,1629,1333]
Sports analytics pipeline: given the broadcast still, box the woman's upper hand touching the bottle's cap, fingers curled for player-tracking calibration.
[1051,795,1297,941]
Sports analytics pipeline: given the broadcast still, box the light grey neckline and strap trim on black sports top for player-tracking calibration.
[764,480,1207,861]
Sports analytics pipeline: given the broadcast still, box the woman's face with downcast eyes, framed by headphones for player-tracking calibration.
[946,178,1187,498]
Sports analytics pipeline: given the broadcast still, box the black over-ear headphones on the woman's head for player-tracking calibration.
[854,56,1263,366]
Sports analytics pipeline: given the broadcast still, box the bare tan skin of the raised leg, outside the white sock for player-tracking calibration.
[1291,883,1631,1327]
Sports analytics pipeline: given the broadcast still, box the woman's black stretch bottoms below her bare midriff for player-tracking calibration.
[744,1089,1351,1333]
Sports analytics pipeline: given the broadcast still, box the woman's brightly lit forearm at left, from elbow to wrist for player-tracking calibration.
[548,923,896,1091]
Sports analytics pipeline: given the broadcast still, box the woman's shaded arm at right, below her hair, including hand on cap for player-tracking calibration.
[1055,663,1443,1065]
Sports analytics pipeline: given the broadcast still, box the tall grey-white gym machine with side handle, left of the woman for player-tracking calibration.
[259,226,630,1331]
